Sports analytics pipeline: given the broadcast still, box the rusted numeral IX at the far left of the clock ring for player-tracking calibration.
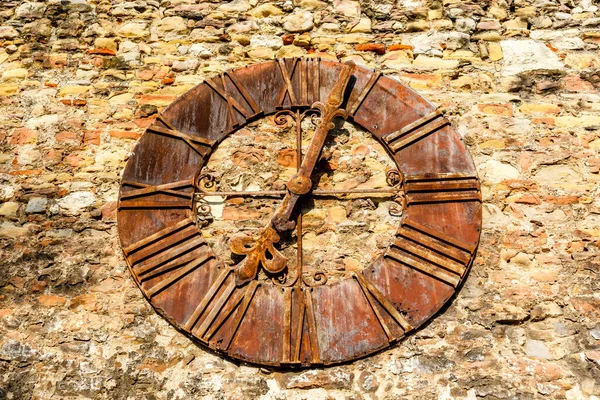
[117,180,193,210]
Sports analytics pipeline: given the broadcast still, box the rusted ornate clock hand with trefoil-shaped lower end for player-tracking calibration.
[230,61,354,286]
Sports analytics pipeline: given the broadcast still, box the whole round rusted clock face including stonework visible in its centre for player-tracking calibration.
[118,58,481,366]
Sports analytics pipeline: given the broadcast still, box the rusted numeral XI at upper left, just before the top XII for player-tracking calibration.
[205,72,262,129]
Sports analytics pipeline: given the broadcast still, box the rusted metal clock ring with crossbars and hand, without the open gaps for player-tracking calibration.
[118,58,481,366]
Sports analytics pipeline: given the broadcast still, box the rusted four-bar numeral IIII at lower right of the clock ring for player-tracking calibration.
[385,218,475,287]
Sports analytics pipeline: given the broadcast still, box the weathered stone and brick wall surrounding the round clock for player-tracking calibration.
[0,0,600,399]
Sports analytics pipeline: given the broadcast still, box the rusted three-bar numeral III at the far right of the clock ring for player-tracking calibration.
[404,173,481,205]
